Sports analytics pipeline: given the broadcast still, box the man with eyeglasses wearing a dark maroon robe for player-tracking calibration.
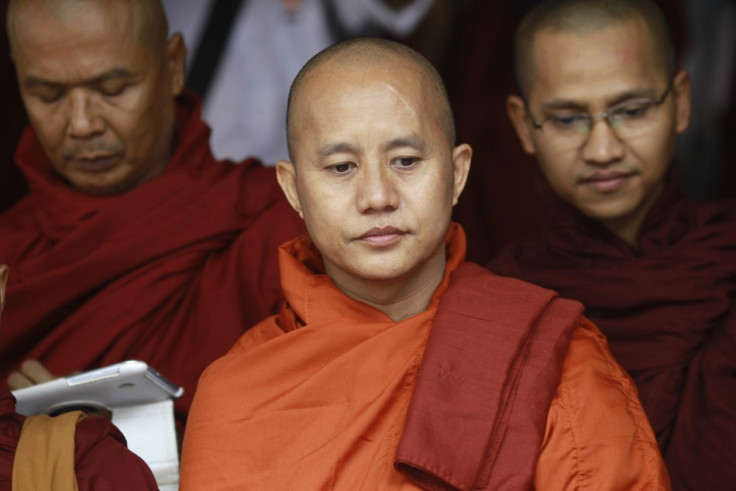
[490,0,736,490]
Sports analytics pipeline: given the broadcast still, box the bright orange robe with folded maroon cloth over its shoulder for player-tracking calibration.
[181,225,668,491]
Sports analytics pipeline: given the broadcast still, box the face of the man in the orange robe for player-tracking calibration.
[278,59,470,289]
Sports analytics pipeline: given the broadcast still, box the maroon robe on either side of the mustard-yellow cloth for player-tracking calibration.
[0,389,158,491]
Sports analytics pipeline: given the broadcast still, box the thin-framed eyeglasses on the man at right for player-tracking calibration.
[527,79,672,145]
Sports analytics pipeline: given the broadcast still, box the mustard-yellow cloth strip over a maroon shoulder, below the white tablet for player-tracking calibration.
[13,411,84,491]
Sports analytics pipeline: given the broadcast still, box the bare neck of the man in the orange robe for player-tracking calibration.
[327,248,445,322]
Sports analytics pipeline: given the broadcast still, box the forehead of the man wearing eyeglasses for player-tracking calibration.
[530,21,666,100]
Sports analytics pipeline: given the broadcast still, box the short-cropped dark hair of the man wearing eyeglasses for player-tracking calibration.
[514,0,675,97]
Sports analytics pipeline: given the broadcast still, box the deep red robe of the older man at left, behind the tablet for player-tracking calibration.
[0,93,303,424]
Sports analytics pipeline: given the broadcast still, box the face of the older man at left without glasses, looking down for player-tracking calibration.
[13,1,185,194]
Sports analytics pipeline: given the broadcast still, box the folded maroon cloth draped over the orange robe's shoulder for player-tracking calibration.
[396,263,584,490]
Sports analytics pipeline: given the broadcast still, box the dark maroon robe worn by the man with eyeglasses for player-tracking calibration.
[490,171,736,490]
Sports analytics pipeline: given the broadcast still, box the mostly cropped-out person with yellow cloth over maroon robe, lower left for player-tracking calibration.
[0,265,158,491]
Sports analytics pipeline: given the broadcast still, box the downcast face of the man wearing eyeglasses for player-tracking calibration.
[509,21,690,239]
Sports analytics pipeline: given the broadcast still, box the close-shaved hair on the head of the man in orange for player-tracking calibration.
[286,37,455,162]
